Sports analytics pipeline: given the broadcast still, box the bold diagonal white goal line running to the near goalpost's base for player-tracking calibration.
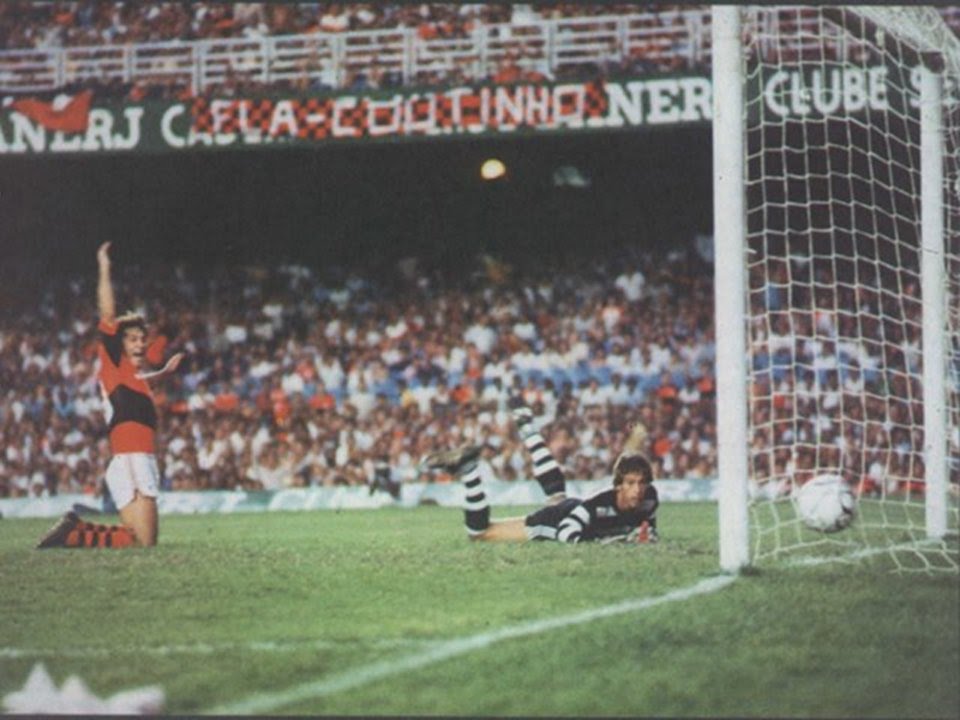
[206,575,736,715]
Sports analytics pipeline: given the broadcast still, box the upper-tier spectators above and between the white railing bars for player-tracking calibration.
[0,0,704,100]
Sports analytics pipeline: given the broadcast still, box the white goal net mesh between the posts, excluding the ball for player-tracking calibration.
[744,7,960,571]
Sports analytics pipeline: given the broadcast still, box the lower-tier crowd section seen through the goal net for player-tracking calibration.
[751,251,932,500]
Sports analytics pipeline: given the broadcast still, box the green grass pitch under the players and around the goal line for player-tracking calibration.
[0,504,960,718]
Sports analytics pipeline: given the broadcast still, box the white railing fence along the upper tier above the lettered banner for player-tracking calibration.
[0,7,709,92]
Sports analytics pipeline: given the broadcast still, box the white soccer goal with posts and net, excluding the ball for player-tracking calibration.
[712,6,960,572]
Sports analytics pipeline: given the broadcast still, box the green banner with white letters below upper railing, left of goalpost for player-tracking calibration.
[0,74,712,155]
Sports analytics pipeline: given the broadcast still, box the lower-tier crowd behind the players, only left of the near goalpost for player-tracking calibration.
[0,242,728,496]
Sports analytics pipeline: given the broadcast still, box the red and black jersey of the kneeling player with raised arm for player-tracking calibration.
[98,320,157,454]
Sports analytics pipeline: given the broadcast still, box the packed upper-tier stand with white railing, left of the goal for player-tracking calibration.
[0,2,709,99]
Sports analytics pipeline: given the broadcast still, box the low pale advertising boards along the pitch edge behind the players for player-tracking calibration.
[0,479,717,518]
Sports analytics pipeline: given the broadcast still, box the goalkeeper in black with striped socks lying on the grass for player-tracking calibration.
[423,406,659,543]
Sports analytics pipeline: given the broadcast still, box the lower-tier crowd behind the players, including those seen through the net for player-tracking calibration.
[0,229,944,497]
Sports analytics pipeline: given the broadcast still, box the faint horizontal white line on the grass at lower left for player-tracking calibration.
[0,639,437,660]
